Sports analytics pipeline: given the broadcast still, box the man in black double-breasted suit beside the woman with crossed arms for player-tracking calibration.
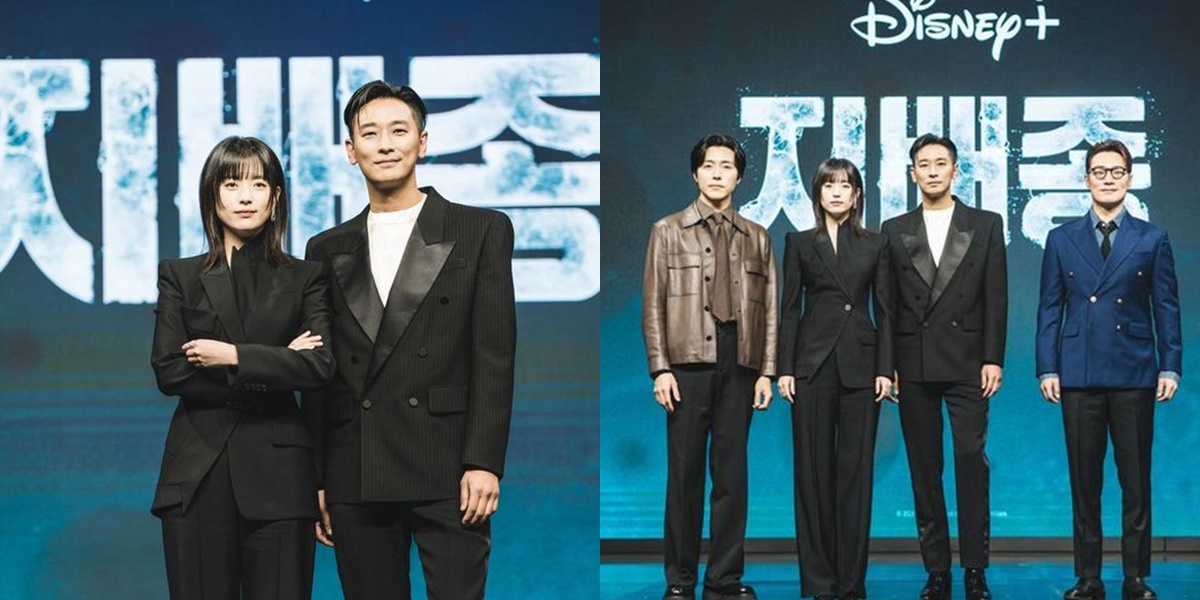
[307,82,516,600]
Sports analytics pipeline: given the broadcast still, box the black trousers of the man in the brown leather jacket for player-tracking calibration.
[662,324,758,587]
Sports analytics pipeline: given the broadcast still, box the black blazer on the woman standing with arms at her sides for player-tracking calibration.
[779,226,894,388]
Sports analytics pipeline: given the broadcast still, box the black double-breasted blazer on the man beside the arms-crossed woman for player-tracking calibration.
[306,187,516,503]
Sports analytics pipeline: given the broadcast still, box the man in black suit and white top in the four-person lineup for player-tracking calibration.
[881,133,1008,600]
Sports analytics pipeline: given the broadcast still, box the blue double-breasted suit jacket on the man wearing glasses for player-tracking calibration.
[1037,214,1183,389]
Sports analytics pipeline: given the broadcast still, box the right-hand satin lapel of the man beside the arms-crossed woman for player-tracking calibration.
[367,193,455,385]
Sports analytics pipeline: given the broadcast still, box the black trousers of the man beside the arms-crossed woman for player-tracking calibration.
[329,498,492,600]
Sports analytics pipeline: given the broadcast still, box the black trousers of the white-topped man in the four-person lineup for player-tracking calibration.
[900,374,991,571]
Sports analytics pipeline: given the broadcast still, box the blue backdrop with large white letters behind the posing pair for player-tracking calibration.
[0,0,600,600]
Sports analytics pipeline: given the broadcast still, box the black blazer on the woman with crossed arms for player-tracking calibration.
[150,250,334,520]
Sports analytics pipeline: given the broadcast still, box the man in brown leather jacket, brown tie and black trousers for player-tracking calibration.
[642,134,778,600]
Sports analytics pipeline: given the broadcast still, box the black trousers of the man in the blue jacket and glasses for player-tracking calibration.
[1062,389,1154,577]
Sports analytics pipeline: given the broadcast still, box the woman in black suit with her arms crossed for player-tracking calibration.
[151,137,334,600]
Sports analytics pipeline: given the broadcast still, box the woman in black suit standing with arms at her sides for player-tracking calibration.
[779,158,893,600]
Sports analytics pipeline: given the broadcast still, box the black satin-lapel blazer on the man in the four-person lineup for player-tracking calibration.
[881,198,1008,382]
